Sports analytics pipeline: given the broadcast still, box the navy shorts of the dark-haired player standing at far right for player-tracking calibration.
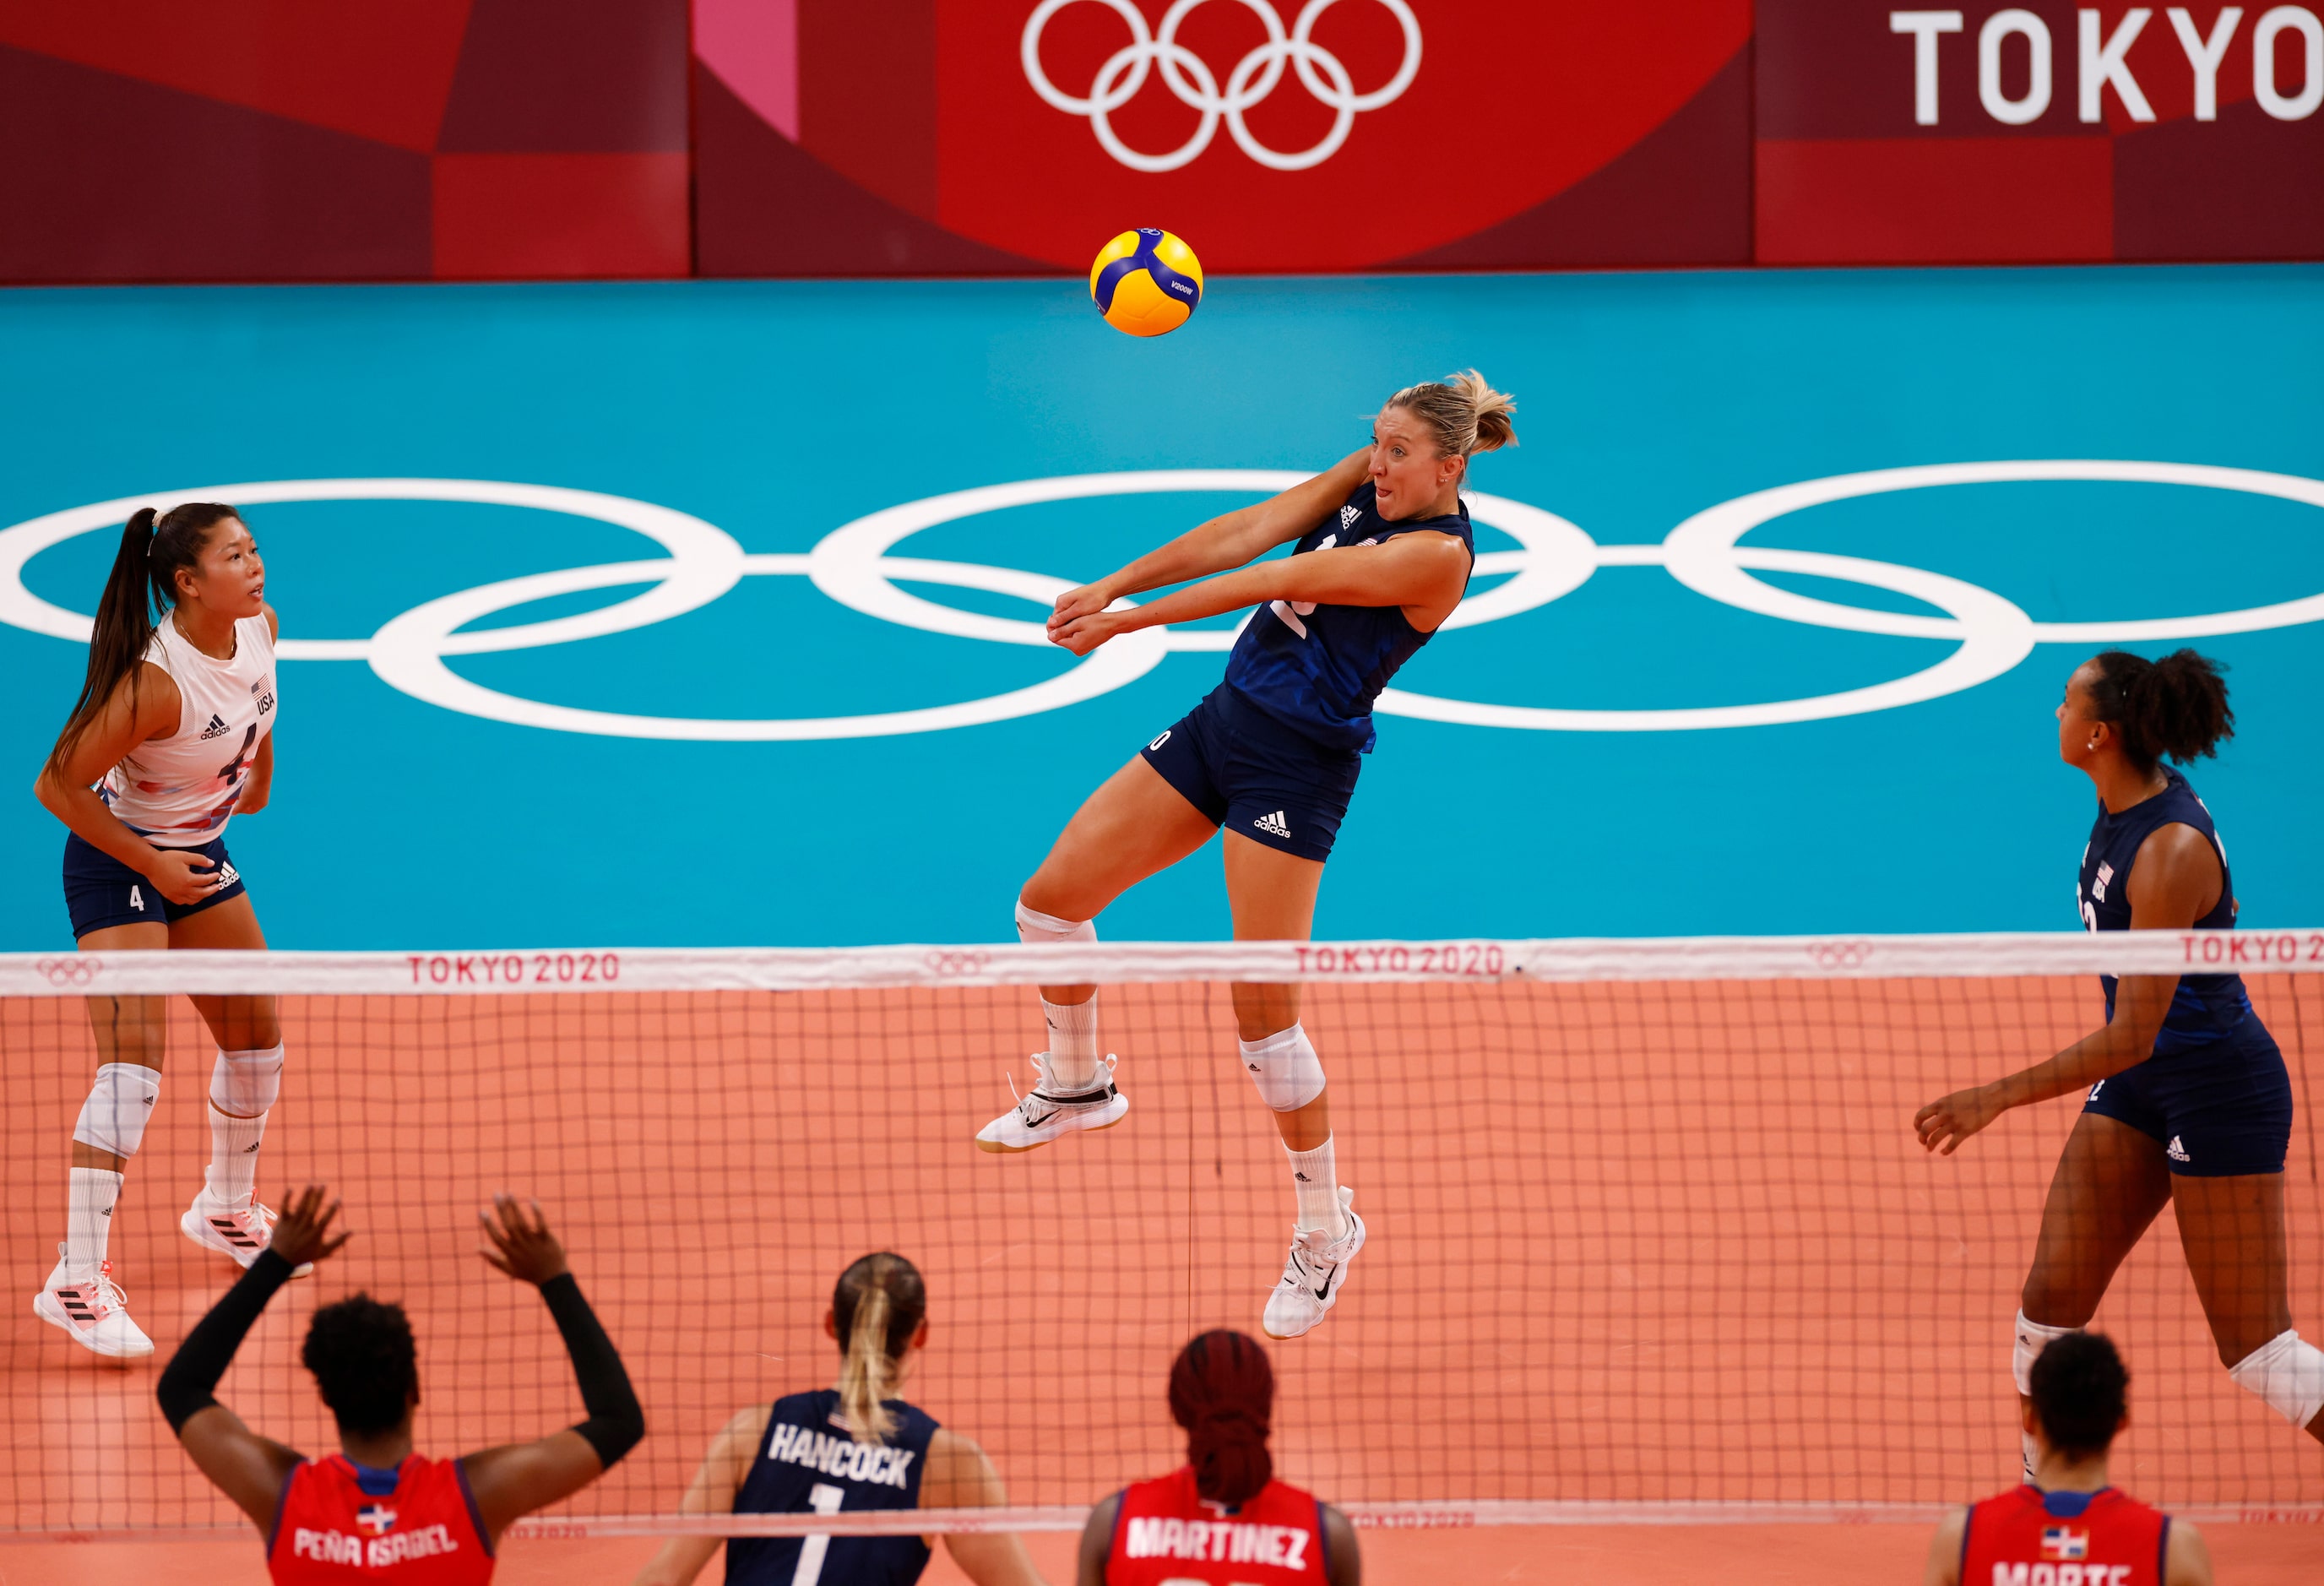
[2082,1014,2291,1179]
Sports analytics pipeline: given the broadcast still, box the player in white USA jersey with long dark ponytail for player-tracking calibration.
[33,502,290,1355]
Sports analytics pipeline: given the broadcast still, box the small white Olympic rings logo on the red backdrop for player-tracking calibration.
[1018,0,1420,172]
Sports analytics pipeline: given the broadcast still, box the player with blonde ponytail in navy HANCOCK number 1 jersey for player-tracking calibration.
[634,1251,1041,1586]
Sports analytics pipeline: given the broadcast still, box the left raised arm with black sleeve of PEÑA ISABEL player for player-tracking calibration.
[154,1184,346,1534]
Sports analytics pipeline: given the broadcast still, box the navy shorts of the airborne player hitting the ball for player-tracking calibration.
[1143,684,1364,861]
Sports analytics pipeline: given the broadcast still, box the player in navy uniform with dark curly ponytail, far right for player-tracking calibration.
[1915,649,2324,1469]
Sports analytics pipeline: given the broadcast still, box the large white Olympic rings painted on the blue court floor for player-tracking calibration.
[0,460,2324,741]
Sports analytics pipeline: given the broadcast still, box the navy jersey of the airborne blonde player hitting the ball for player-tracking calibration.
[1227,479,1476,753]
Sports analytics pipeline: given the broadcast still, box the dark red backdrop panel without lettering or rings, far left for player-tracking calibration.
[0,0,692,281]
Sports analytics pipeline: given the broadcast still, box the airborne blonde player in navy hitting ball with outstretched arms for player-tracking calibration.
[976,370,1515,1337]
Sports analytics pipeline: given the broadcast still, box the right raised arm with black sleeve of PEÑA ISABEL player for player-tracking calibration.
[460,1195,646,1544]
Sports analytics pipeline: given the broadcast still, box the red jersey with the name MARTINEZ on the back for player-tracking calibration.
[1106,1465,1325,1586]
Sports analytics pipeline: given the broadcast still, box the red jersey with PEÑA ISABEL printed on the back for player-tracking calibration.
[267,1453,492,1586]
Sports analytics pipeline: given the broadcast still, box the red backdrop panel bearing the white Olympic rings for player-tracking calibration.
[695,0,1750,274]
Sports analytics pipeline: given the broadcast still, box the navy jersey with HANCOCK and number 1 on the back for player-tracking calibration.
[727,1388,937,1586]
